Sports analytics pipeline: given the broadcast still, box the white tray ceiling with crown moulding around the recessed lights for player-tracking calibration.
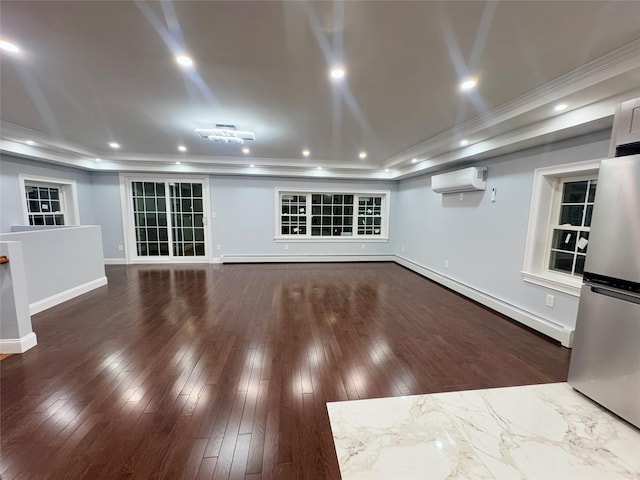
[0,0,640,178]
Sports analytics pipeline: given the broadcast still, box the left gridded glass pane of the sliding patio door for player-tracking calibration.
[131,182,169,257]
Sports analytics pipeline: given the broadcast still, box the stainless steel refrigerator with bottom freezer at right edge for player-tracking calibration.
[568,155,640,427]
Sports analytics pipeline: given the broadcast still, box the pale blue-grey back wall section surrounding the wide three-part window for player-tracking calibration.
[210,177,396,256]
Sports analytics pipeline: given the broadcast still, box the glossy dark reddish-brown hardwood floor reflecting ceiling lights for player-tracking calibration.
[0,263,569,480]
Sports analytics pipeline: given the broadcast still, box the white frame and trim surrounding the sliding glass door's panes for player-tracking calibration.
[119,173,214,265]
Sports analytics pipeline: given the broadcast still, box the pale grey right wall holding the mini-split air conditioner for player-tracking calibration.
[395,132,609,336]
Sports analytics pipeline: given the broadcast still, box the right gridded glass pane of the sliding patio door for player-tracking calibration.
[169,182,205,257]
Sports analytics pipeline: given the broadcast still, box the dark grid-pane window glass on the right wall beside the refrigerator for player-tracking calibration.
[549,178,597,277]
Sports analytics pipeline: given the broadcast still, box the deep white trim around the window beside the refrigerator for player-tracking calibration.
[520,159,601,297]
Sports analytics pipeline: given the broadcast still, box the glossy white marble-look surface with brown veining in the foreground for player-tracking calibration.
[327,383,640,480]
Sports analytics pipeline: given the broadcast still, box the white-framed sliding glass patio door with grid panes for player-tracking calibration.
[121,178,210,263]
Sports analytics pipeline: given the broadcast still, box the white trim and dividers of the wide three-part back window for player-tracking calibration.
[273,187,391,243]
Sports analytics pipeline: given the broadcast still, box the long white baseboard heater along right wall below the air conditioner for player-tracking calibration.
[395,255,574,348]
